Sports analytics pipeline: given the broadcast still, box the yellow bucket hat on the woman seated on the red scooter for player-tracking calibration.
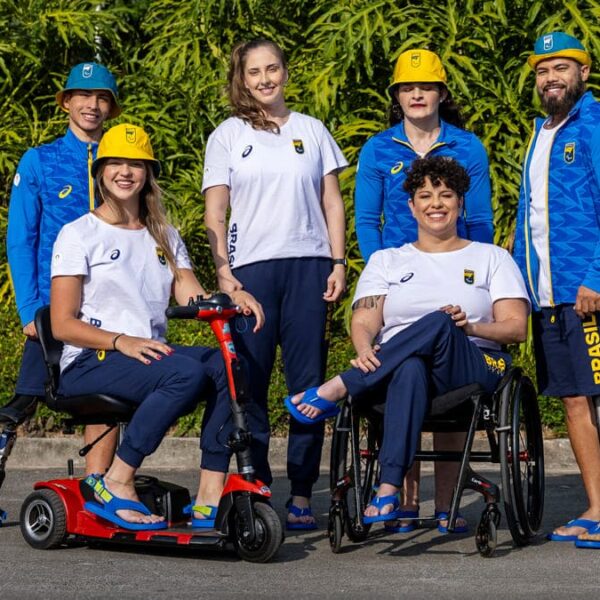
[92,123,160,177]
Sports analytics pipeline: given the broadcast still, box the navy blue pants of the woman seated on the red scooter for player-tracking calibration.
[60,346,231,473]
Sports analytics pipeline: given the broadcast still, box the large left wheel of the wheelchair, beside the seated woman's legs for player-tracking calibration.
[331,404,377,542]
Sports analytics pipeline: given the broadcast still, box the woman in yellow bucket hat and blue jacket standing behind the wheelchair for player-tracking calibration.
[355,48,493,532]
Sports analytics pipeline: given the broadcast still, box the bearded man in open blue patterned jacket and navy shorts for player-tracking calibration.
[515,32,600,547]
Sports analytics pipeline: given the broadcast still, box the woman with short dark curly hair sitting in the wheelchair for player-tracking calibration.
[286,156,529,523]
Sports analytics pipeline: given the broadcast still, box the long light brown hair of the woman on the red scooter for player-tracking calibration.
[95,160,179,279]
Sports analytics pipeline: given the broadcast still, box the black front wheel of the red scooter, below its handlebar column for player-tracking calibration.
[234,502,283,563]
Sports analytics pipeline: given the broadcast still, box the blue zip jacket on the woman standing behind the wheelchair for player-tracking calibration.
[354,121,494,262]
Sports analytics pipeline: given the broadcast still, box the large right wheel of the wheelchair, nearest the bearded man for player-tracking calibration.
[498,370,544,546]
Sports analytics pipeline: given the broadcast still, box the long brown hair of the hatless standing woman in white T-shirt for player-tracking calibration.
[227,38,287,133]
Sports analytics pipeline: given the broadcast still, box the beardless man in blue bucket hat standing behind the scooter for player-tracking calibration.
[0,62,121,473]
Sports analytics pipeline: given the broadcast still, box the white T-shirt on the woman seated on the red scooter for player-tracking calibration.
[52,213,192,371]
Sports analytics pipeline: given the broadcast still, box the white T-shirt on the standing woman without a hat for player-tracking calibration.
[202,112,348,268]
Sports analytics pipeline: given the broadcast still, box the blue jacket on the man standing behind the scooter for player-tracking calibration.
[6,129,98,325]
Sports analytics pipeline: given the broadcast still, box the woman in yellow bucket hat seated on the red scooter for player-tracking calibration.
[50,124,264,529]
